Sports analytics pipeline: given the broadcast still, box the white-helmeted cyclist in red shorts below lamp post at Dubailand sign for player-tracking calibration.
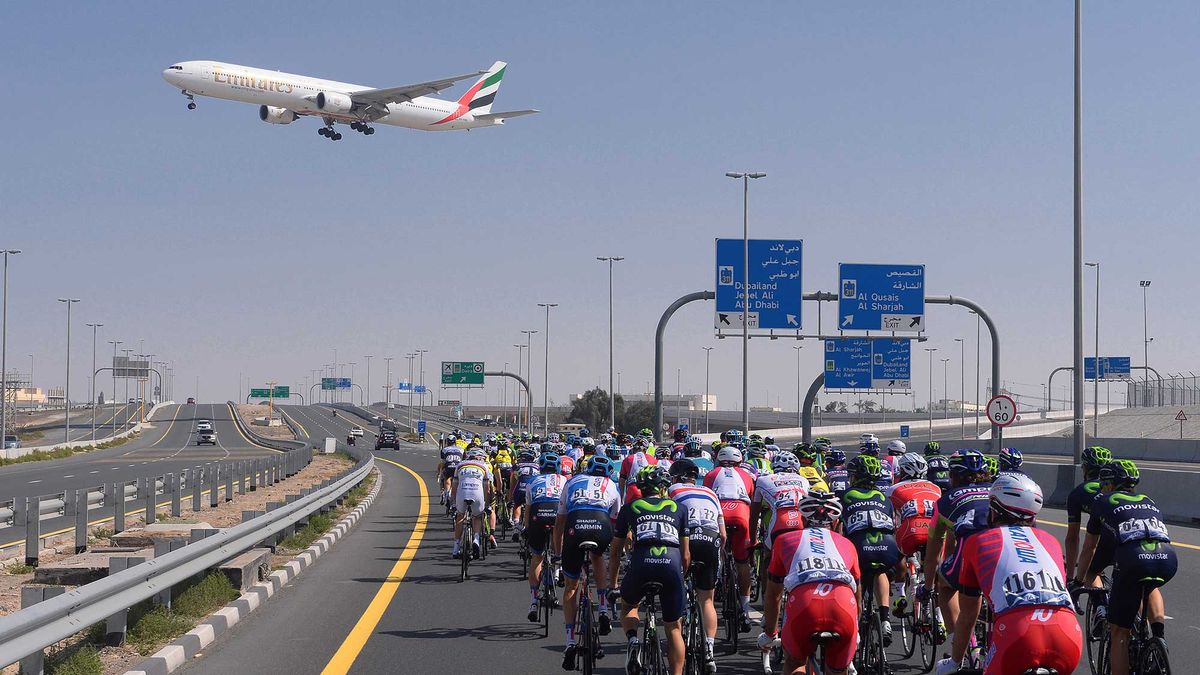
[704,446,755,633]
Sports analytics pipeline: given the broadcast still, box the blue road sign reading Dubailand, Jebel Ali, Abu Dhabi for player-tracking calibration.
[715,239,804,331]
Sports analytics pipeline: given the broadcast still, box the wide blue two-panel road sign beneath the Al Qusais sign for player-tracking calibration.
[824,338,912,389]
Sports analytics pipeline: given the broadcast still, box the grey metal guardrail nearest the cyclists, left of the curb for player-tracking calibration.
[0,455,374,665]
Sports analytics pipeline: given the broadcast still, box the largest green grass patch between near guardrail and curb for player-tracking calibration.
[127,572,238,656]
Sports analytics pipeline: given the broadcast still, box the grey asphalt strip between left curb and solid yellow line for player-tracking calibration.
[184,452,437,674]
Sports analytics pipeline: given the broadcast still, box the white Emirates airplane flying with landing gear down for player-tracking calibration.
[162,61,539,141]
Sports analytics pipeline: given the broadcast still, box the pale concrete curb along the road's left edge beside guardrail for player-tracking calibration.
[125,468,383,675]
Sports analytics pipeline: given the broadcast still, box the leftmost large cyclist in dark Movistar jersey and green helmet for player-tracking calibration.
[608,465,691,675]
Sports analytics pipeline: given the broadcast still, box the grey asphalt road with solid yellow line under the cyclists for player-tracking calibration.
[177,406,1200,675]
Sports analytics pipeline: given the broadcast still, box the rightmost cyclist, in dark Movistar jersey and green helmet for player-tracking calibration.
[1073,459,1180,675]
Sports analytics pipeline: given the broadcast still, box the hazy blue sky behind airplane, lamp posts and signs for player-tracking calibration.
[0,1,1200,407]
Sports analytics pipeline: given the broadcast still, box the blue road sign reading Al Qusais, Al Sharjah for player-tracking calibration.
[838,263,925,333]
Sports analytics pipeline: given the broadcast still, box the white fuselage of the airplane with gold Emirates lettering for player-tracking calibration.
[163,61,496,131]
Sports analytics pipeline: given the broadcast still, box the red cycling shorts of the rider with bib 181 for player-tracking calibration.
[780,581,858,670]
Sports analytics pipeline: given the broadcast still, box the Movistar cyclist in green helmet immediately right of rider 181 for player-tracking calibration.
[841,455,900,646]
